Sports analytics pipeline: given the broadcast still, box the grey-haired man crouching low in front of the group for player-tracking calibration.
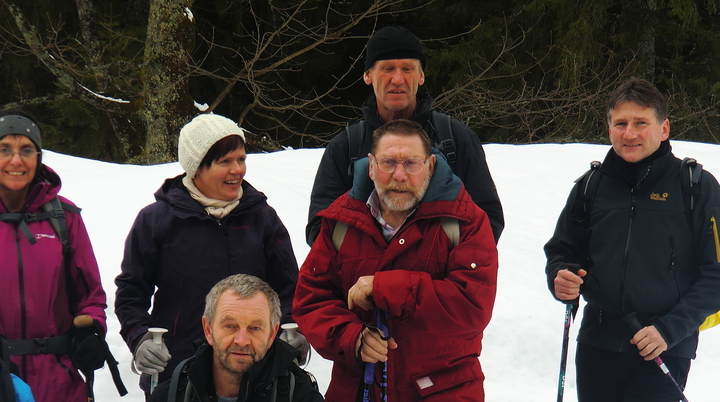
[149,274,323,402]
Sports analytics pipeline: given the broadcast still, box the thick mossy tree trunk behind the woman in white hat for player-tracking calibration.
[138,0,197,164]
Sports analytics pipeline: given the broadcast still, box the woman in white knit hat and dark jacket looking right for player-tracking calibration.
[115,114,308,393]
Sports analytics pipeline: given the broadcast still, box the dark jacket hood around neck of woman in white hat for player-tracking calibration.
[155,173,267,219]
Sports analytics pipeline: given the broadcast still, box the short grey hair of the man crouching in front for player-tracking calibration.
[203,274,282,326]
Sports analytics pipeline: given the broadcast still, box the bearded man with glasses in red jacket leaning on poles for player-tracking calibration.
[293,120,498,402]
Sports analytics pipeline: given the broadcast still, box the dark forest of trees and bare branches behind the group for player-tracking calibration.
[0,0,720,164]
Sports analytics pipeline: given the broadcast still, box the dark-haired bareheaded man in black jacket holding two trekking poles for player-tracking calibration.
[545,79,720,402]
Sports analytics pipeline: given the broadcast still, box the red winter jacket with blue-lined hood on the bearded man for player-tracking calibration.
[293,155,498,402]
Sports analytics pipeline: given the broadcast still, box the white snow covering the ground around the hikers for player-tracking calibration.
[43,141,720,402]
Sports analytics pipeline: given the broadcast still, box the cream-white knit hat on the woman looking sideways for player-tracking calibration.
[178,113,245,178]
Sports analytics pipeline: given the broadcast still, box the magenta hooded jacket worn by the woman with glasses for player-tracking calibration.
[0,165,107,402]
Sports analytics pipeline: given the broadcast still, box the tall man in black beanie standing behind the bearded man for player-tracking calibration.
[305,26,505,246]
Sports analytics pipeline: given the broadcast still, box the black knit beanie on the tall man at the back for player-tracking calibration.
[365,26,425,71]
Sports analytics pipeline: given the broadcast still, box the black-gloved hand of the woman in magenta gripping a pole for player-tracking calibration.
[70,315,106,372]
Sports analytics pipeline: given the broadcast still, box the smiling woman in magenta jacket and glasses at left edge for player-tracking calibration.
[0,113,106,402]
